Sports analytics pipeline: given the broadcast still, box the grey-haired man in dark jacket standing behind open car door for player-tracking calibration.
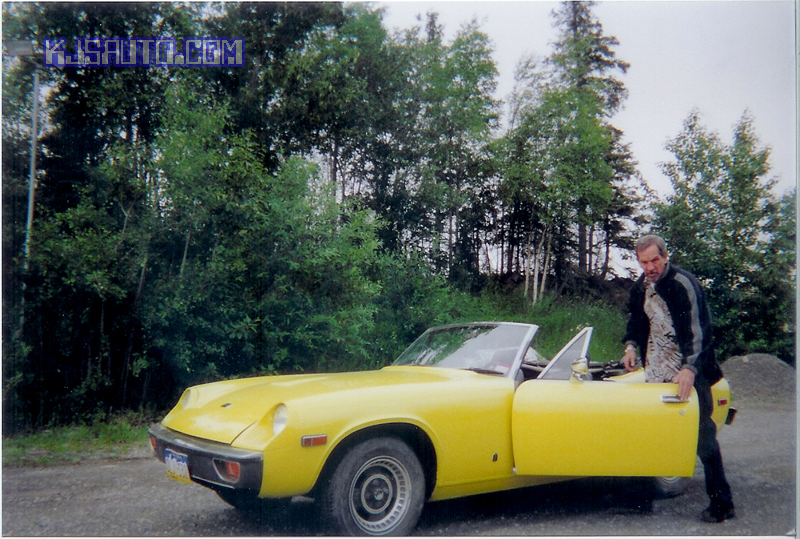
[622,235,736,522]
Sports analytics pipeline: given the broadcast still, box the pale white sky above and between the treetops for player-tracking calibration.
[377,0,798,197]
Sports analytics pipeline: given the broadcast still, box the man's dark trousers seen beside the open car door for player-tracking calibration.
[695,380,733,507]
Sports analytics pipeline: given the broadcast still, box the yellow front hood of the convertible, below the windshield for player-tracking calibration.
[162,367,479,444]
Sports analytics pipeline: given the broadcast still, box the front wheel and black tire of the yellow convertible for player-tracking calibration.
[321,437,425,536]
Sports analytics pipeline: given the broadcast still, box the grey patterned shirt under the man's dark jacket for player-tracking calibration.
[644,281,683,383]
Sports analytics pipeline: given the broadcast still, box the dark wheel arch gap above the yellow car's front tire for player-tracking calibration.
[312,422,437,499]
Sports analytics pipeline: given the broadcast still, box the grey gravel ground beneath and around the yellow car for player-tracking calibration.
[2,357,797,536]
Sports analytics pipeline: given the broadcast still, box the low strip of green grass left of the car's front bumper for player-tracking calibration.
[3,415,150,467]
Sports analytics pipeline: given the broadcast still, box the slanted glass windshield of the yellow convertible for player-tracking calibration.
[394,323,537,376]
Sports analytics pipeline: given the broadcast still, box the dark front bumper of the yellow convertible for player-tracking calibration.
[148,424,264,492]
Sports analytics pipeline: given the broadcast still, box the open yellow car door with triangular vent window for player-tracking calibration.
[511,328,699,477]
